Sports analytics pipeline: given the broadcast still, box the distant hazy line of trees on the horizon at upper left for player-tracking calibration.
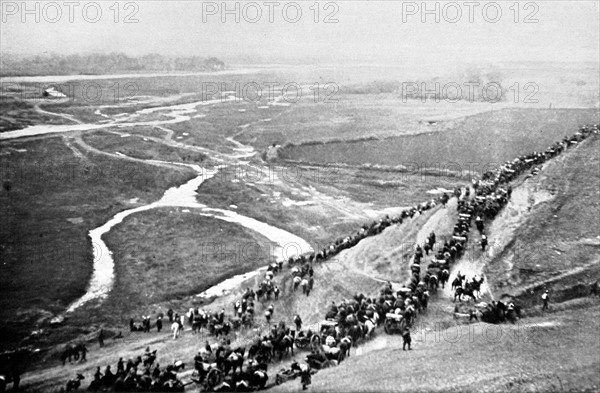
[0,53,225,76]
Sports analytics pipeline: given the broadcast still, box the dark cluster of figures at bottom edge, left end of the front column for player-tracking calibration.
[66,347,185,392]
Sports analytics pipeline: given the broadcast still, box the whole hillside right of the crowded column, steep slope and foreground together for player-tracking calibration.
[273,136,600,392]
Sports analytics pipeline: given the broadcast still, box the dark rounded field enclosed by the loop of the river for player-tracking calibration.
[98,208,272,318]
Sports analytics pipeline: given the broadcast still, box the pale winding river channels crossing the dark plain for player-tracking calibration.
[0,86,312,312]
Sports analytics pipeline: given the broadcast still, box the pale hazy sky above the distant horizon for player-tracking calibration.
[0,0,600,63]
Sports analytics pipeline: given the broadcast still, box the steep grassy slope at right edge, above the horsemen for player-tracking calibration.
[486,136,600,304]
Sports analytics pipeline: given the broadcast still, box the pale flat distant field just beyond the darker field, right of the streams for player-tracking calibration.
[233,92,498,149]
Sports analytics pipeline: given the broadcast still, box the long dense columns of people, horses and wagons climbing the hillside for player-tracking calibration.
[57,125,598,391]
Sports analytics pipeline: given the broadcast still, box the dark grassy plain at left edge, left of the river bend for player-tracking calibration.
[0,138,193,345]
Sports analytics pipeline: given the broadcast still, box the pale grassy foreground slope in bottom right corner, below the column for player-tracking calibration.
[271,302,600,392]
